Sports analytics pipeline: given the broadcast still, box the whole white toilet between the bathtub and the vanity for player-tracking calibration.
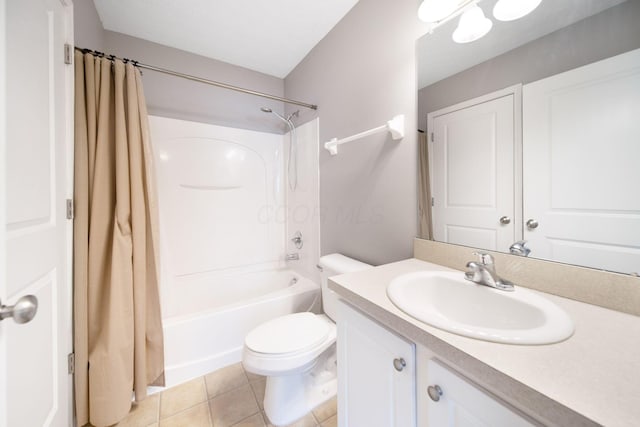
[242,254,371,426]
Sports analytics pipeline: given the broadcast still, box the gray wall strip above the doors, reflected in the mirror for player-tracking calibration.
[418,0,640,129]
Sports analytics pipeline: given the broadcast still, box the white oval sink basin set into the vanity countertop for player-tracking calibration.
[387,271,573,344]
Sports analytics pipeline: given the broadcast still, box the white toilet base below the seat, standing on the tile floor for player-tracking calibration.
[264,344,338,427]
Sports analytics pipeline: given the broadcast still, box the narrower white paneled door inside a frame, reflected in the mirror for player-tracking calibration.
[427,87,521,252]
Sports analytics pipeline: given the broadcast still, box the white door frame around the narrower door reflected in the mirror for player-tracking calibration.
[427,83,524,246]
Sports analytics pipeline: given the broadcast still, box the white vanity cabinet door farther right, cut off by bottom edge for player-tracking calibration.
[425,360,536,427]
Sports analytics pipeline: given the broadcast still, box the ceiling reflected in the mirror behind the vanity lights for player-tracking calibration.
[416,0,624,89]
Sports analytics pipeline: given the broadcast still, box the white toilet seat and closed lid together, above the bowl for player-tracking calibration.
[242,312,337,376]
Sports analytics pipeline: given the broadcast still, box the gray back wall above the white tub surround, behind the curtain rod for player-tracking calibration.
[74,0,285,133]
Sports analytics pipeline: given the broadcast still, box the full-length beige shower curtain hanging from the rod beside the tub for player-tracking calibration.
[74,52,164,426]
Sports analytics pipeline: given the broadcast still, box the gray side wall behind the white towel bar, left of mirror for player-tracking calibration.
[285,0,424,264]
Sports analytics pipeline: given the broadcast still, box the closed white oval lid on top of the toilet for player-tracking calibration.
[245,312,330,354]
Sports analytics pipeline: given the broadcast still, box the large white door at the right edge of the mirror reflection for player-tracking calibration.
[523,50,640,273]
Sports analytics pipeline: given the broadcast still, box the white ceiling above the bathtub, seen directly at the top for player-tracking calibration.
[94,0,358,78]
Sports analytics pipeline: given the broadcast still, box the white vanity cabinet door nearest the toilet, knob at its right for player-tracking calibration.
[338,302,416,427]
